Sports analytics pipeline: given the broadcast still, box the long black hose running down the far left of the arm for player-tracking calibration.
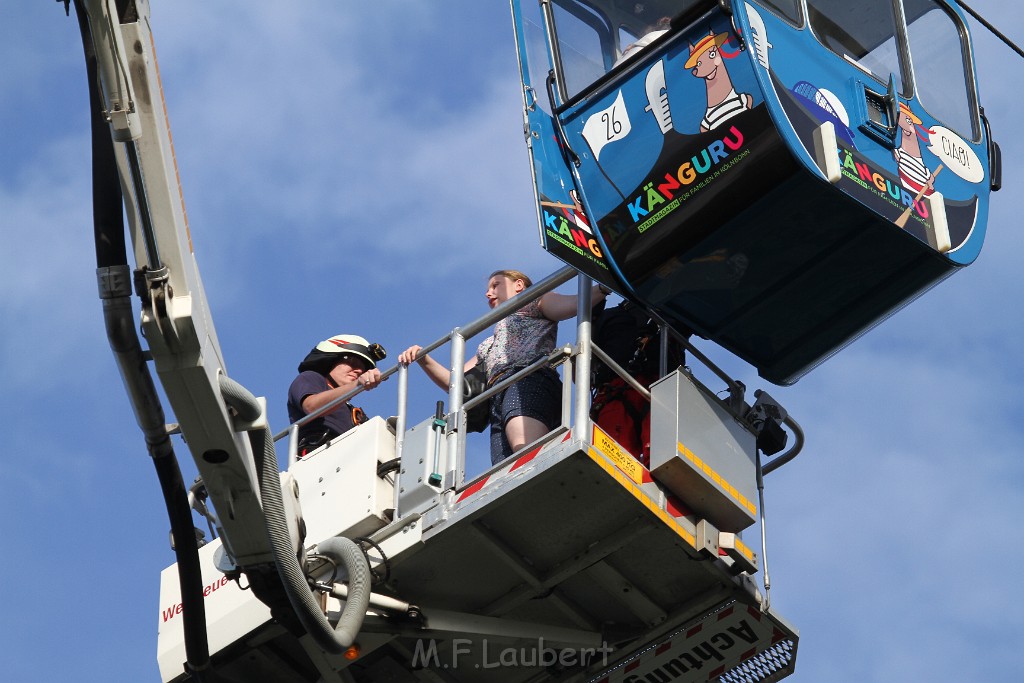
[75,0,210,681]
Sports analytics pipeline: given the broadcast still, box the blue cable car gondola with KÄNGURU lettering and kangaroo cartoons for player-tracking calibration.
[512,0,998,384]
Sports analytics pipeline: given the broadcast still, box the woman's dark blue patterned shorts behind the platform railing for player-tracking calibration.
[490,368,562,465]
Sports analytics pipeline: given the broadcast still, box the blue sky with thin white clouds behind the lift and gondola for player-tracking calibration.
[0,0,1024,683]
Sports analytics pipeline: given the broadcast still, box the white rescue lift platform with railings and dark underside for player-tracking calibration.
[160,268,802,681]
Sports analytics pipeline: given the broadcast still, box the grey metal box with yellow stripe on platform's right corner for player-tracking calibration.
[650,370,757,531]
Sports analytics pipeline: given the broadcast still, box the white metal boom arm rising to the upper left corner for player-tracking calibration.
[86,0,272,566]
